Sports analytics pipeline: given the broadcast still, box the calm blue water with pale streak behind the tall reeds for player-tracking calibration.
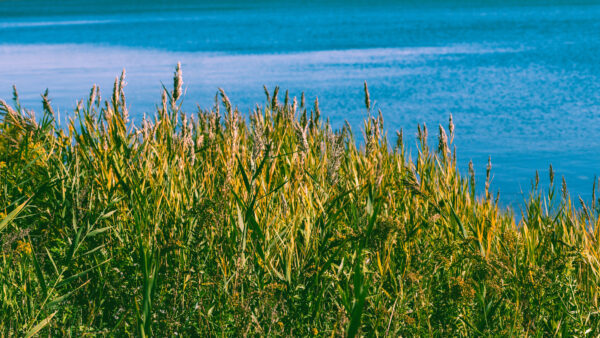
[0,0,600,204]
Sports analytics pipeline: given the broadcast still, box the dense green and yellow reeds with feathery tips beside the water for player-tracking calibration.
[0,69,600,337]
